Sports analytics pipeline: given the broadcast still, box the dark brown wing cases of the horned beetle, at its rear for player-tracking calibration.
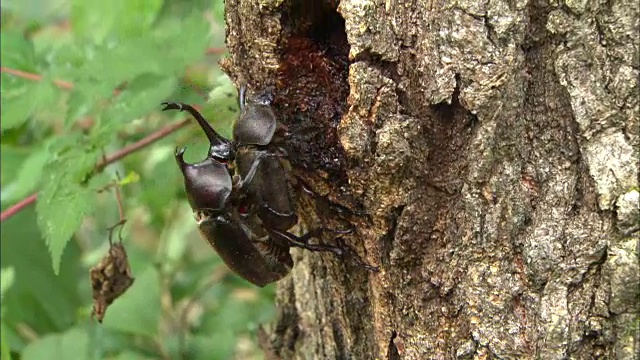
[199,216,293,287]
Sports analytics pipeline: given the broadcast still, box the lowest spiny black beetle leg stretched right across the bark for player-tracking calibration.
[267,228,380,272]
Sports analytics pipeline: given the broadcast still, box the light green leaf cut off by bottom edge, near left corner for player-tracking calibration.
[21,328,91,360]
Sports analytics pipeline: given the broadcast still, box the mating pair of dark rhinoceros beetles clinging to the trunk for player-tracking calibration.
[163,87,378,286]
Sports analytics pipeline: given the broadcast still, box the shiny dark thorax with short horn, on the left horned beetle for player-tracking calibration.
[175,148,233,211]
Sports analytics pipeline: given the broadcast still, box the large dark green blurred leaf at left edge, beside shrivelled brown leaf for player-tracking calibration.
[0,207,87,342]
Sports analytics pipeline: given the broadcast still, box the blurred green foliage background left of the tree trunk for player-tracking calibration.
[0,0,275,360]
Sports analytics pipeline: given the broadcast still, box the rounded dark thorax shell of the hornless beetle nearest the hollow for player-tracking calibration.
[233,104,277,146]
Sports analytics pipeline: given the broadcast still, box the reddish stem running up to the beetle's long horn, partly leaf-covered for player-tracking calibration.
[0,119,189,222]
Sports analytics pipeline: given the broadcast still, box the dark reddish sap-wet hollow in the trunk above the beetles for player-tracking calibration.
[274,0,349,186]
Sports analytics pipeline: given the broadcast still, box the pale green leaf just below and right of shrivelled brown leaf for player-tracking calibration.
[102,266,161,337]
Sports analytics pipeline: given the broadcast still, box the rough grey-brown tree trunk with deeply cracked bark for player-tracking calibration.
[222,0,640,359]
